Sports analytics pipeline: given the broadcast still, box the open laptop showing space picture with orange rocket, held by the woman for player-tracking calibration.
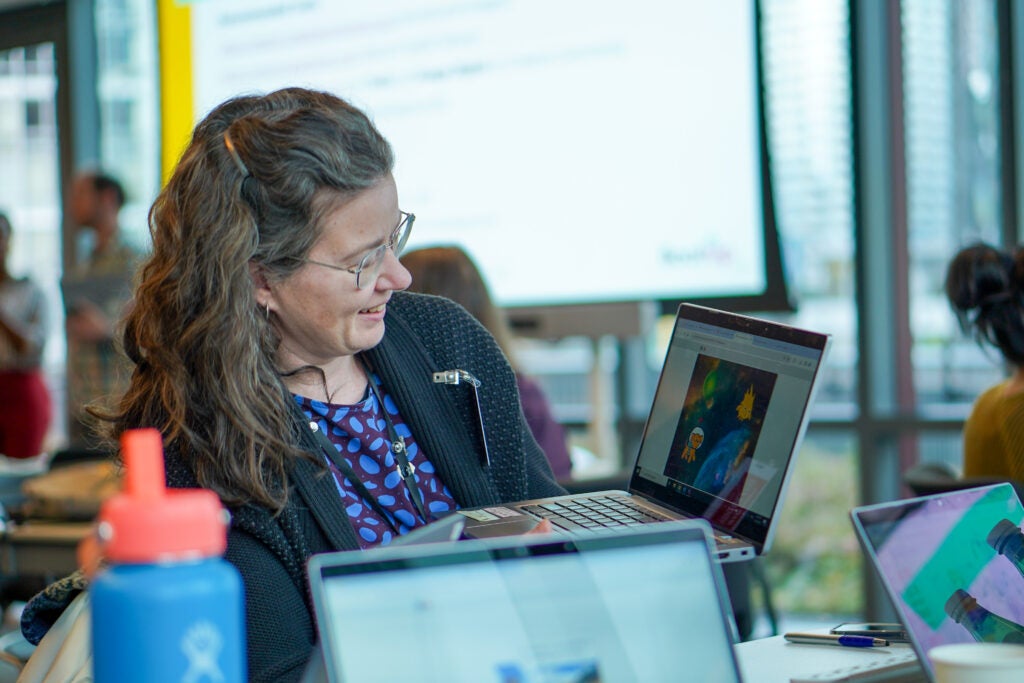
[459,304,830,561]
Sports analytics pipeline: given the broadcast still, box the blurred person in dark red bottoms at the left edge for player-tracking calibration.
[0,213,53,458]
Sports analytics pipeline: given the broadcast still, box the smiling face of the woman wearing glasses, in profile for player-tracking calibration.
[266,175,412,369]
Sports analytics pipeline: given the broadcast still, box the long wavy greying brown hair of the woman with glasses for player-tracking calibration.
[95,88,393,510]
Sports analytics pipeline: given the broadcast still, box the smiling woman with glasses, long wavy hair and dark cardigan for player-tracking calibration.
[23,88,561,681]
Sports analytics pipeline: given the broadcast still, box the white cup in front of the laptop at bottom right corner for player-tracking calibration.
[928,643,1024,683]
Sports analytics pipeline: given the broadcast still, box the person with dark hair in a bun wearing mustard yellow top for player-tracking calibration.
[946,244,1024,481]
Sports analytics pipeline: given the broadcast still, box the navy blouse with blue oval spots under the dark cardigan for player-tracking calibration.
[295,375,458,548]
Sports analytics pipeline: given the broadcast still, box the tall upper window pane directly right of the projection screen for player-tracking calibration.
[761,0,857,414]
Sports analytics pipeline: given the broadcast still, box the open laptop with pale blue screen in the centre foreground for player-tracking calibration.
[307,521,740,683]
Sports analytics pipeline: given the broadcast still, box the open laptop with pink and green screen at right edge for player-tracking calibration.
[850,483,1024,680]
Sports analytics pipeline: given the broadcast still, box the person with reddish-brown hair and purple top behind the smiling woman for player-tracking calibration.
[401,246,572,480]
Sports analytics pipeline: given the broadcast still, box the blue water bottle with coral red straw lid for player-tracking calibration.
[89,429,246,683]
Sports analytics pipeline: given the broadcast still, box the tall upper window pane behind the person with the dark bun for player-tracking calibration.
[902,0,1001,421]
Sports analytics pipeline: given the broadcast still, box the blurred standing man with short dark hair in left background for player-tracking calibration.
[63,170,140,447]
